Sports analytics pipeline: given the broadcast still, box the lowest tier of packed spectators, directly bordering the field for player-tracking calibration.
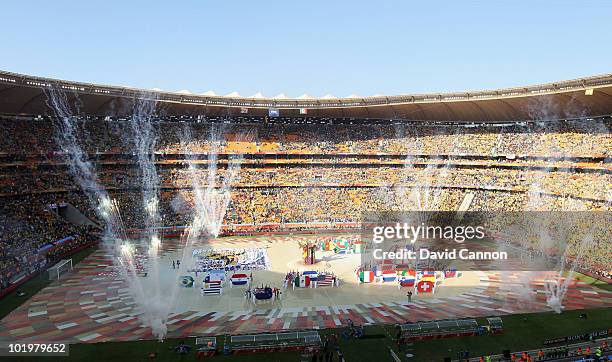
[0,187,612,284]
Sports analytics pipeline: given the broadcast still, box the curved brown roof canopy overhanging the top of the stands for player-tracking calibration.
[0,71,612,122]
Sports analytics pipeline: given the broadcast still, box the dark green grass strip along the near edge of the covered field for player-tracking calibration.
[6,308,612,362]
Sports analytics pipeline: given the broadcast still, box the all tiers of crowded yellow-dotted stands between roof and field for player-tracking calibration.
[0,117,612,287]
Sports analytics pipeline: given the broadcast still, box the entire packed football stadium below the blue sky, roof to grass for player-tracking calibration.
[0,2,612,362]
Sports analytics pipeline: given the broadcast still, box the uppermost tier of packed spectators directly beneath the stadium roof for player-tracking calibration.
[0,118,611,158]
